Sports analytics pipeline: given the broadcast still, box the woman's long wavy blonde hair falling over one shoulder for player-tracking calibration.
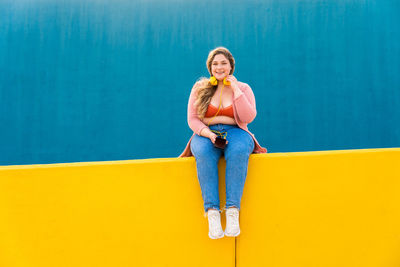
[194,47,235,119]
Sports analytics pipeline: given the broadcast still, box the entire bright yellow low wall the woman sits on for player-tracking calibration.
[0,148,400,267]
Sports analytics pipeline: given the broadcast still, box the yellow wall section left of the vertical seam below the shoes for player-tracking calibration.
[0,159,235,267]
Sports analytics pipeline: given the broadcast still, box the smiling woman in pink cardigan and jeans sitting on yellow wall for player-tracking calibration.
[179,47,267,239]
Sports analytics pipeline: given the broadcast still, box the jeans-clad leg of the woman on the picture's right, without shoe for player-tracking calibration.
[224,128,254,209]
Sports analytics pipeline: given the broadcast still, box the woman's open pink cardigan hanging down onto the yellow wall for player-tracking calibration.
[179,81,267,157]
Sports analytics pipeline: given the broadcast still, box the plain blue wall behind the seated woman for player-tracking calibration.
[0,0,400,165]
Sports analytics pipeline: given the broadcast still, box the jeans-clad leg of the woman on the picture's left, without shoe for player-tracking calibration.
[190,134,222,212]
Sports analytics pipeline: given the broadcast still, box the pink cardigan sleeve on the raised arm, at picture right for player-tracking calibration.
[233,83,257,123]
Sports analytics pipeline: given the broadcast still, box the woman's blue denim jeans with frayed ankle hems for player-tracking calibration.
[190,124,254,212]
